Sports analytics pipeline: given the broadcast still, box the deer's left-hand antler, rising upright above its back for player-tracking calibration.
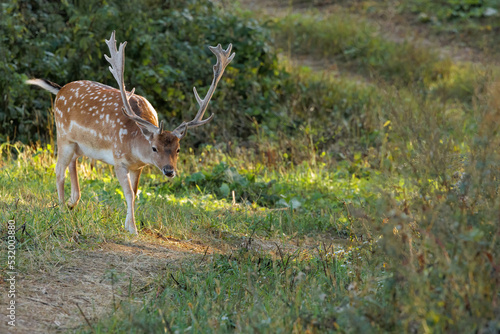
[104,31,163,133]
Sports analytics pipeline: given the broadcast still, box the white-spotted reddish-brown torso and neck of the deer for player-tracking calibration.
[54,81,158,164]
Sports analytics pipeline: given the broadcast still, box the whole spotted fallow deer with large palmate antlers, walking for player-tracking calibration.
[26,32,235,234]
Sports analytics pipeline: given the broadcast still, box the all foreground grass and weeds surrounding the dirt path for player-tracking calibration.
[0,104,498,333]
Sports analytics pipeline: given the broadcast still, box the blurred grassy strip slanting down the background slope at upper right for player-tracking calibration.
[273,9,498,103]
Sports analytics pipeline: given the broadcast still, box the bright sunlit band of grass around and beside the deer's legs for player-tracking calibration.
[0,142,376,254]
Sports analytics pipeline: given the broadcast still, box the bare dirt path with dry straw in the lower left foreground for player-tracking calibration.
[0,238,217,333]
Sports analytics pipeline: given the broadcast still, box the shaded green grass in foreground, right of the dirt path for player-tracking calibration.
[91,248,364,333]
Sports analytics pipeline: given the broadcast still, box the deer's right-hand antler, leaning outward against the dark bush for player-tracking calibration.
[172,44,235,139]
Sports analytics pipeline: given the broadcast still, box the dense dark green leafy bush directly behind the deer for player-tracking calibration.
[0,0,281,143]
